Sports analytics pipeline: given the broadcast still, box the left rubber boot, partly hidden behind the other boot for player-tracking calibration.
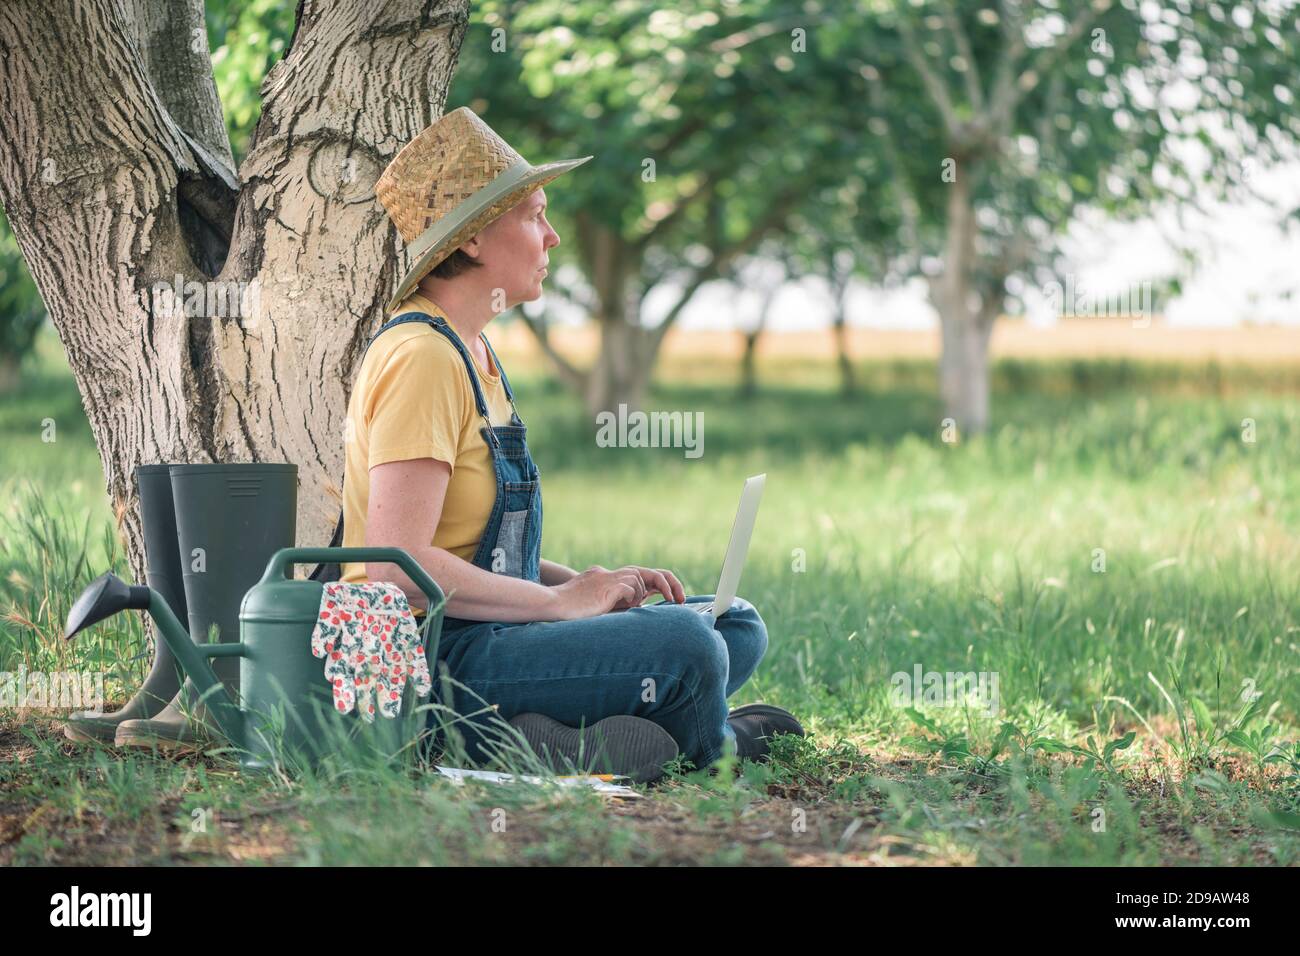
[64,464,187,744]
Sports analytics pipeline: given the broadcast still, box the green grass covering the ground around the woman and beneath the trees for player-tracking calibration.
[0,327,1300,865]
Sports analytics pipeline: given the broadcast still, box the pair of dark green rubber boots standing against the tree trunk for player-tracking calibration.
[64,463,298,750]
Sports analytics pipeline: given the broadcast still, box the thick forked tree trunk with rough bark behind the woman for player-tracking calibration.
[0,0,468,580]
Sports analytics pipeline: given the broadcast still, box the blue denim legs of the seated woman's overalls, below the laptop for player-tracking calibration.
[434,594,767,767]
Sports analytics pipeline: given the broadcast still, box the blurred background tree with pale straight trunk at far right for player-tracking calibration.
[820,0,1300,431]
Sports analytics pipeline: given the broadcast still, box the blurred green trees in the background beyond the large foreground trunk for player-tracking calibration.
[0,0,1300,431]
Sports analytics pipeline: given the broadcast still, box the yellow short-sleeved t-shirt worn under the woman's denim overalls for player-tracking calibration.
[341,293,511,583]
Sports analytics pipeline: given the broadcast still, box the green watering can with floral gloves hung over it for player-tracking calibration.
[64,548,445,770]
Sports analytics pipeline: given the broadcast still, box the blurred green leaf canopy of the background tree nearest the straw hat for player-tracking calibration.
[446,0,892,283]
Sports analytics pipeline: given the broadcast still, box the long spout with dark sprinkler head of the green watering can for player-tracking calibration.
[64,571,244,747]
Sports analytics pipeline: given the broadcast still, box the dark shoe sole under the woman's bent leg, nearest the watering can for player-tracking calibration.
[510,714,677,783]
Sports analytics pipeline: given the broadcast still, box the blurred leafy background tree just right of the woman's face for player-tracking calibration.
[449,0,875,414]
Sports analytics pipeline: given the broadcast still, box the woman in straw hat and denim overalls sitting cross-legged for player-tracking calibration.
[317,108,803,782]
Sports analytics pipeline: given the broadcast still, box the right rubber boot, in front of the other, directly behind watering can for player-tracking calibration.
[116,463,298,750]
